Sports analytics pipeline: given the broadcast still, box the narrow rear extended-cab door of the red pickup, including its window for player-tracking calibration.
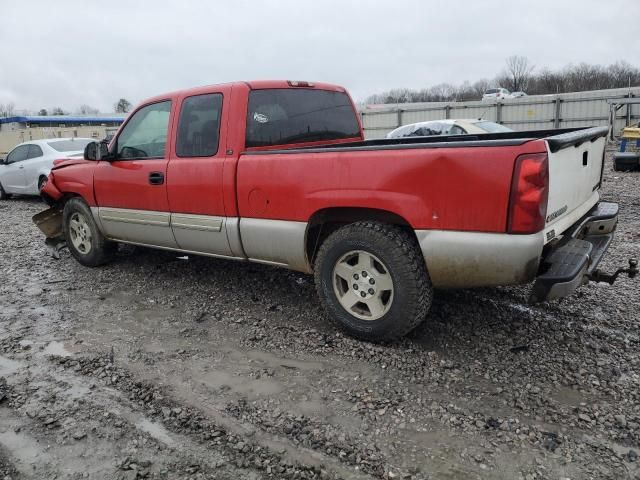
[167,87,238,256]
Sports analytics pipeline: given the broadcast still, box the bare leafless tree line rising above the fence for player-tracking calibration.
[365,55,640,104]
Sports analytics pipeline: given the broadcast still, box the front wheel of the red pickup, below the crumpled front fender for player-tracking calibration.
[62,197,117,267]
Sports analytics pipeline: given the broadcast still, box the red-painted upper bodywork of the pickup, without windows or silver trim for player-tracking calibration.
[46,81,546,236]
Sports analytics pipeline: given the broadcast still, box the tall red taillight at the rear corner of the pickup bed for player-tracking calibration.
[507,153,549,233]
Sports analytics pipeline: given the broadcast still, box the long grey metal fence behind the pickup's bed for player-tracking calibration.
[360,87,640,138]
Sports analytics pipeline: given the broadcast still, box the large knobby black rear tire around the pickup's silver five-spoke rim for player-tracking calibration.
[314,221,433,341]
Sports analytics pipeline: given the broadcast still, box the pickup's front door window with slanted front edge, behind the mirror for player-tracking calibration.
[116,100,171,160]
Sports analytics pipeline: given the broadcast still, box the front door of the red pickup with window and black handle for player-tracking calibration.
[93,99,177,248]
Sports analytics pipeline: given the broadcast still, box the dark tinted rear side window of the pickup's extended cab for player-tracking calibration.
[176,93,222,157]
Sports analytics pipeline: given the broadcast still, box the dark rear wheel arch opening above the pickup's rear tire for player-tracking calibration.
[305,207,417,269]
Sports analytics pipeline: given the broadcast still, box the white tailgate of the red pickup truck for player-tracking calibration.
[544,127,608,243]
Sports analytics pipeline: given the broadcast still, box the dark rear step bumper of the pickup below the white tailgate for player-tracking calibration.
[530,202,618,302]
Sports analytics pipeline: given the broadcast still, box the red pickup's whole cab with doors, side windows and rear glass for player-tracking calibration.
[42,81,363,264]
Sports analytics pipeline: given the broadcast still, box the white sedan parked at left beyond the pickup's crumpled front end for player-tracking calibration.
[0,138,95,200]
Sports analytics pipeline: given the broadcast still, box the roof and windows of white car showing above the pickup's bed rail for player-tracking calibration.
[387,118,513,138]
